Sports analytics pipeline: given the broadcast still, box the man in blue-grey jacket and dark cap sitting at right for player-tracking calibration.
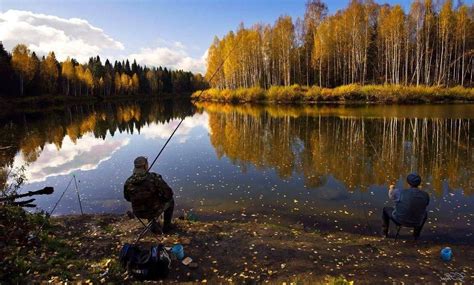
[382,173,430,239]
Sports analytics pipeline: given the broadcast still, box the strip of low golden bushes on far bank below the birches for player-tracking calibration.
[191,84,474,104]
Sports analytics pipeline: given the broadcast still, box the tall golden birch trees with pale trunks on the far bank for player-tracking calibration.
[205,0,474,89]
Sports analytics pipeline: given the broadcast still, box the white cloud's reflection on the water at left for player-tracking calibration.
[14,133,130,183]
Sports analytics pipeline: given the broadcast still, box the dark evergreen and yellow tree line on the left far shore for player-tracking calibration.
[0,42,207,97]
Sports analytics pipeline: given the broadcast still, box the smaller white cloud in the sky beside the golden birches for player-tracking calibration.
[127,40,207,73]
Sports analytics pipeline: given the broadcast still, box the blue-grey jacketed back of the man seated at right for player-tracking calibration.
[393,188,430,226]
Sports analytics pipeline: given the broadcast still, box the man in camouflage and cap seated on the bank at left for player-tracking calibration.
[123,156,174,233]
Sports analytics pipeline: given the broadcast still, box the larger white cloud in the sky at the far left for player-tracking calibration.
[0,10,124,62]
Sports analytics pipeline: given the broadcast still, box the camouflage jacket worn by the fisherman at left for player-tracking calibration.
[123,172,173,218]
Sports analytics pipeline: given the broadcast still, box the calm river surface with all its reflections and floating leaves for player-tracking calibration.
[0,102,474,242]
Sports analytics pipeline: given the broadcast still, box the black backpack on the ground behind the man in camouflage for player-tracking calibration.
[119,243,171,280]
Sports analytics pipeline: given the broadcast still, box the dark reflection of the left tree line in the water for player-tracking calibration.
[0,101,195,187]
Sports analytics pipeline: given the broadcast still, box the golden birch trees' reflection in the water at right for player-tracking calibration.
[198,103,474,195]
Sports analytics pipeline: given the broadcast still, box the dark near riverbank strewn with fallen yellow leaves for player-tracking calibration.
[2,209,474,284]
